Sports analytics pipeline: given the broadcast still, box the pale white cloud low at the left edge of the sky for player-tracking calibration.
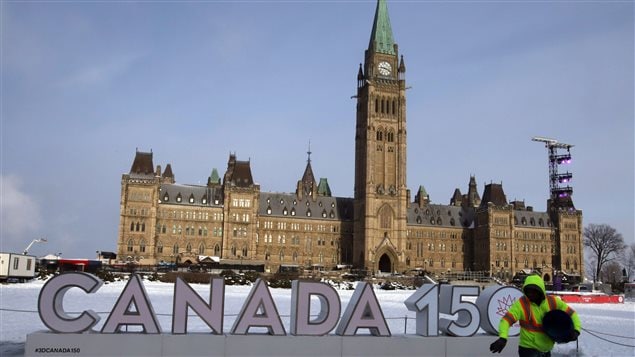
[0,174,42,251]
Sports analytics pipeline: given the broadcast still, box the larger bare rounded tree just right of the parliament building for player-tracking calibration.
[584,224,626,282]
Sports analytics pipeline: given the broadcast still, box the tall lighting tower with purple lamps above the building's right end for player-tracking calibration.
[531,136,573,208]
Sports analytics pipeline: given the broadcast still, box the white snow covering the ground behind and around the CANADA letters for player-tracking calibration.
[0,280,635,357]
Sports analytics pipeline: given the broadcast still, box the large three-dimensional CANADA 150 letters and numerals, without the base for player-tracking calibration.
[38,273,522,337]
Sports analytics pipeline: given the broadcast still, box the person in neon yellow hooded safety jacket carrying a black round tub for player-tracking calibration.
[489,275,582,357]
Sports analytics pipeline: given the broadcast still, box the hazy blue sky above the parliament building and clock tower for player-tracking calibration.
[0,1,635,258]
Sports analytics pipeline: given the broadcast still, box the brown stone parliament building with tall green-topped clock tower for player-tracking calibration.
[117,0,583,280]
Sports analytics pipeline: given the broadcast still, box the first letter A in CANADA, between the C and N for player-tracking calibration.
[101,274,161,334]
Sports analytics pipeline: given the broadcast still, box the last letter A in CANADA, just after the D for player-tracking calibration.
[335,283,390,337]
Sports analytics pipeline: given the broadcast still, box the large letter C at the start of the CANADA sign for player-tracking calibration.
[38,272,103,333]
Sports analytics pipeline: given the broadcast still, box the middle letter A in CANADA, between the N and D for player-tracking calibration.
[231,279,287,336]
